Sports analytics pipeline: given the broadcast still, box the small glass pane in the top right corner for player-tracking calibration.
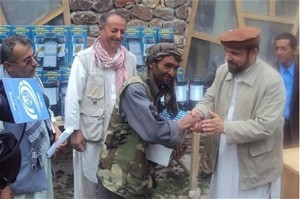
[276,0,299,19]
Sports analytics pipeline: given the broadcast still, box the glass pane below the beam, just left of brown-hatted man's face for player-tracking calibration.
[185,38,225,79]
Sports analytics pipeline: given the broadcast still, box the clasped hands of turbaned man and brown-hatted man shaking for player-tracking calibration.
[178,108,224,135]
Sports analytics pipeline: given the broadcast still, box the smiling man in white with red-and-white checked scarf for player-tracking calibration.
[64,12,136,199]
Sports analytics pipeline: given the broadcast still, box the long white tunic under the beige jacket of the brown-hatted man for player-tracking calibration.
[208,75,280,198]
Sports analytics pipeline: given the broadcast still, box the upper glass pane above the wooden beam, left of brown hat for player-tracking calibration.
[194,0,237,35]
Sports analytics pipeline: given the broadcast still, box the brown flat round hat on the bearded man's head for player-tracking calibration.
[219,26,261,48]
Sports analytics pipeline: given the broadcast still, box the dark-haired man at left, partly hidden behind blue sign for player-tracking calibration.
[0,36,61,199]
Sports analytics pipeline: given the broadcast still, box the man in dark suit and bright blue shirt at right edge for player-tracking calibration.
[274,32,299,148]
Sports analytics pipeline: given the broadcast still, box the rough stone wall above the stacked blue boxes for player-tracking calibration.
[69,0,192,49]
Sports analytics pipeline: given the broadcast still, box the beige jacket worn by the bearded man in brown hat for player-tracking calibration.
[196,58,285,193]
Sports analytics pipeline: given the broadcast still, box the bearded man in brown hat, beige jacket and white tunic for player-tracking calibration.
[192,27,285,198]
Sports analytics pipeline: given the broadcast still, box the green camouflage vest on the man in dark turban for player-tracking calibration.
[97,74,154,199]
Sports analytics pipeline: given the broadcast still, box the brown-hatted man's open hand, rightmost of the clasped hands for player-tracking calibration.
[202,111,224,135]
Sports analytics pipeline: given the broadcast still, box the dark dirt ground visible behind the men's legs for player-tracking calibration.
[52,146,210,199]
